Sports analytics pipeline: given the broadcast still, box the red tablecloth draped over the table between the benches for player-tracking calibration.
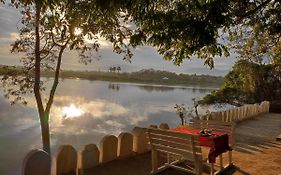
[170,128,231,163]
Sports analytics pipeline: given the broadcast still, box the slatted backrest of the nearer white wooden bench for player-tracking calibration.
[147,128,202,162]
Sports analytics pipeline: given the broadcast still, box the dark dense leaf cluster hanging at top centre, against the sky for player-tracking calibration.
[129,0,230,67]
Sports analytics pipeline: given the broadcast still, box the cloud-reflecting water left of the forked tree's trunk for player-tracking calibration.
[0,96,41,175]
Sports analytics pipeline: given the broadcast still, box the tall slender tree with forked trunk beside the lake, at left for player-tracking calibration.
[2,0,132,153]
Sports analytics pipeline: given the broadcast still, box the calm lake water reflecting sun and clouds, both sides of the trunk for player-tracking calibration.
[0,79,212,175]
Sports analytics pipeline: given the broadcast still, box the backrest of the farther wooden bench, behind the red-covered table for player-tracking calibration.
[189,119,235,146]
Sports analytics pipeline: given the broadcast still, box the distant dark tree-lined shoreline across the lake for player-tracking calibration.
[0,66,224,88]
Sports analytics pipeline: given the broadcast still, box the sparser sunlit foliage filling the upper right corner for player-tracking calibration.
[228,0,281,64]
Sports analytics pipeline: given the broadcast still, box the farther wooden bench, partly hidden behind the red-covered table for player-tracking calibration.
[189,119,235,174]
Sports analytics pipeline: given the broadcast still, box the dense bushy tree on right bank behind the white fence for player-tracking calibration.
[200,60,281,105]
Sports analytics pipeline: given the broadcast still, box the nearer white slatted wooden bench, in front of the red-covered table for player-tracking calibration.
[147,128,203,175]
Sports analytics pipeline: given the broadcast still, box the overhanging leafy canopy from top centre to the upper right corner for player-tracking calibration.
[129,0,281,68]
